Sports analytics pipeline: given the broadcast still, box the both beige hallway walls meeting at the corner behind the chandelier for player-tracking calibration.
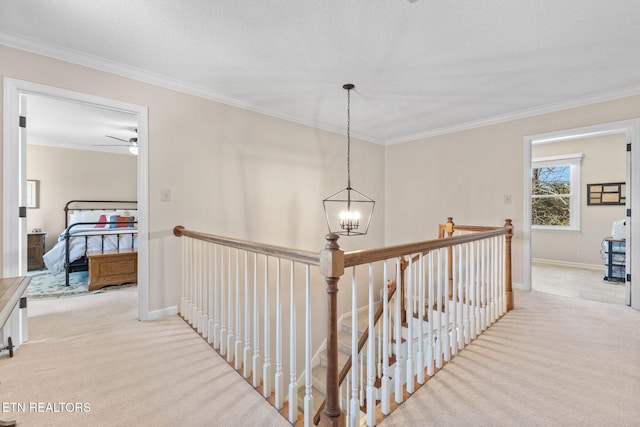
[0,46,640,304]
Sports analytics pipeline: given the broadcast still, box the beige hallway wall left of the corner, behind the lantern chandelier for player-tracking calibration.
[0,46,385,310]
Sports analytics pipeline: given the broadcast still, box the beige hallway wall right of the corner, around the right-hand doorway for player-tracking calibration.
[385,96,640,284]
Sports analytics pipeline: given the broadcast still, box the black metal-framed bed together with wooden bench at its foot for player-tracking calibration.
[43,200,138,290]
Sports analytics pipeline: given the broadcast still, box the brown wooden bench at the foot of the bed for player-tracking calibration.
[87,249,138,291]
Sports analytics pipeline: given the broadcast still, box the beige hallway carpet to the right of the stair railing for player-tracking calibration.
[381,292,640,427]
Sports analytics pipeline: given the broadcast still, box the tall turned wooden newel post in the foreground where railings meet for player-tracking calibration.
[320,233,346,427]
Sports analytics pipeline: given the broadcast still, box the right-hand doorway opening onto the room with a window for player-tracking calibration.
[523,119,640,309]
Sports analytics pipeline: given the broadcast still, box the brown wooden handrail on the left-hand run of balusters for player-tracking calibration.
[173,225,320,265]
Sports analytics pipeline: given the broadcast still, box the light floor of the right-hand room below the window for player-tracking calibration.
[531,262,625,304]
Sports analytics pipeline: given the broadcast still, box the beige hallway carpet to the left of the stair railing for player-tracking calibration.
[0,288,290,427]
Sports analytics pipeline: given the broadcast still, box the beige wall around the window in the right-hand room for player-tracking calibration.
[531,134,627,267]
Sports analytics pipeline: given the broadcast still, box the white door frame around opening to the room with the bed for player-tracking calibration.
[2,77,152,320]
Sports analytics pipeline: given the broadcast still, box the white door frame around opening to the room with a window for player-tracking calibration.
[522,119,640,310]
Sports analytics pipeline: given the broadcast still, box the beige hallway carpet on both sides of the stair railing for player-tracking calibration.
[0,288,640,427]
